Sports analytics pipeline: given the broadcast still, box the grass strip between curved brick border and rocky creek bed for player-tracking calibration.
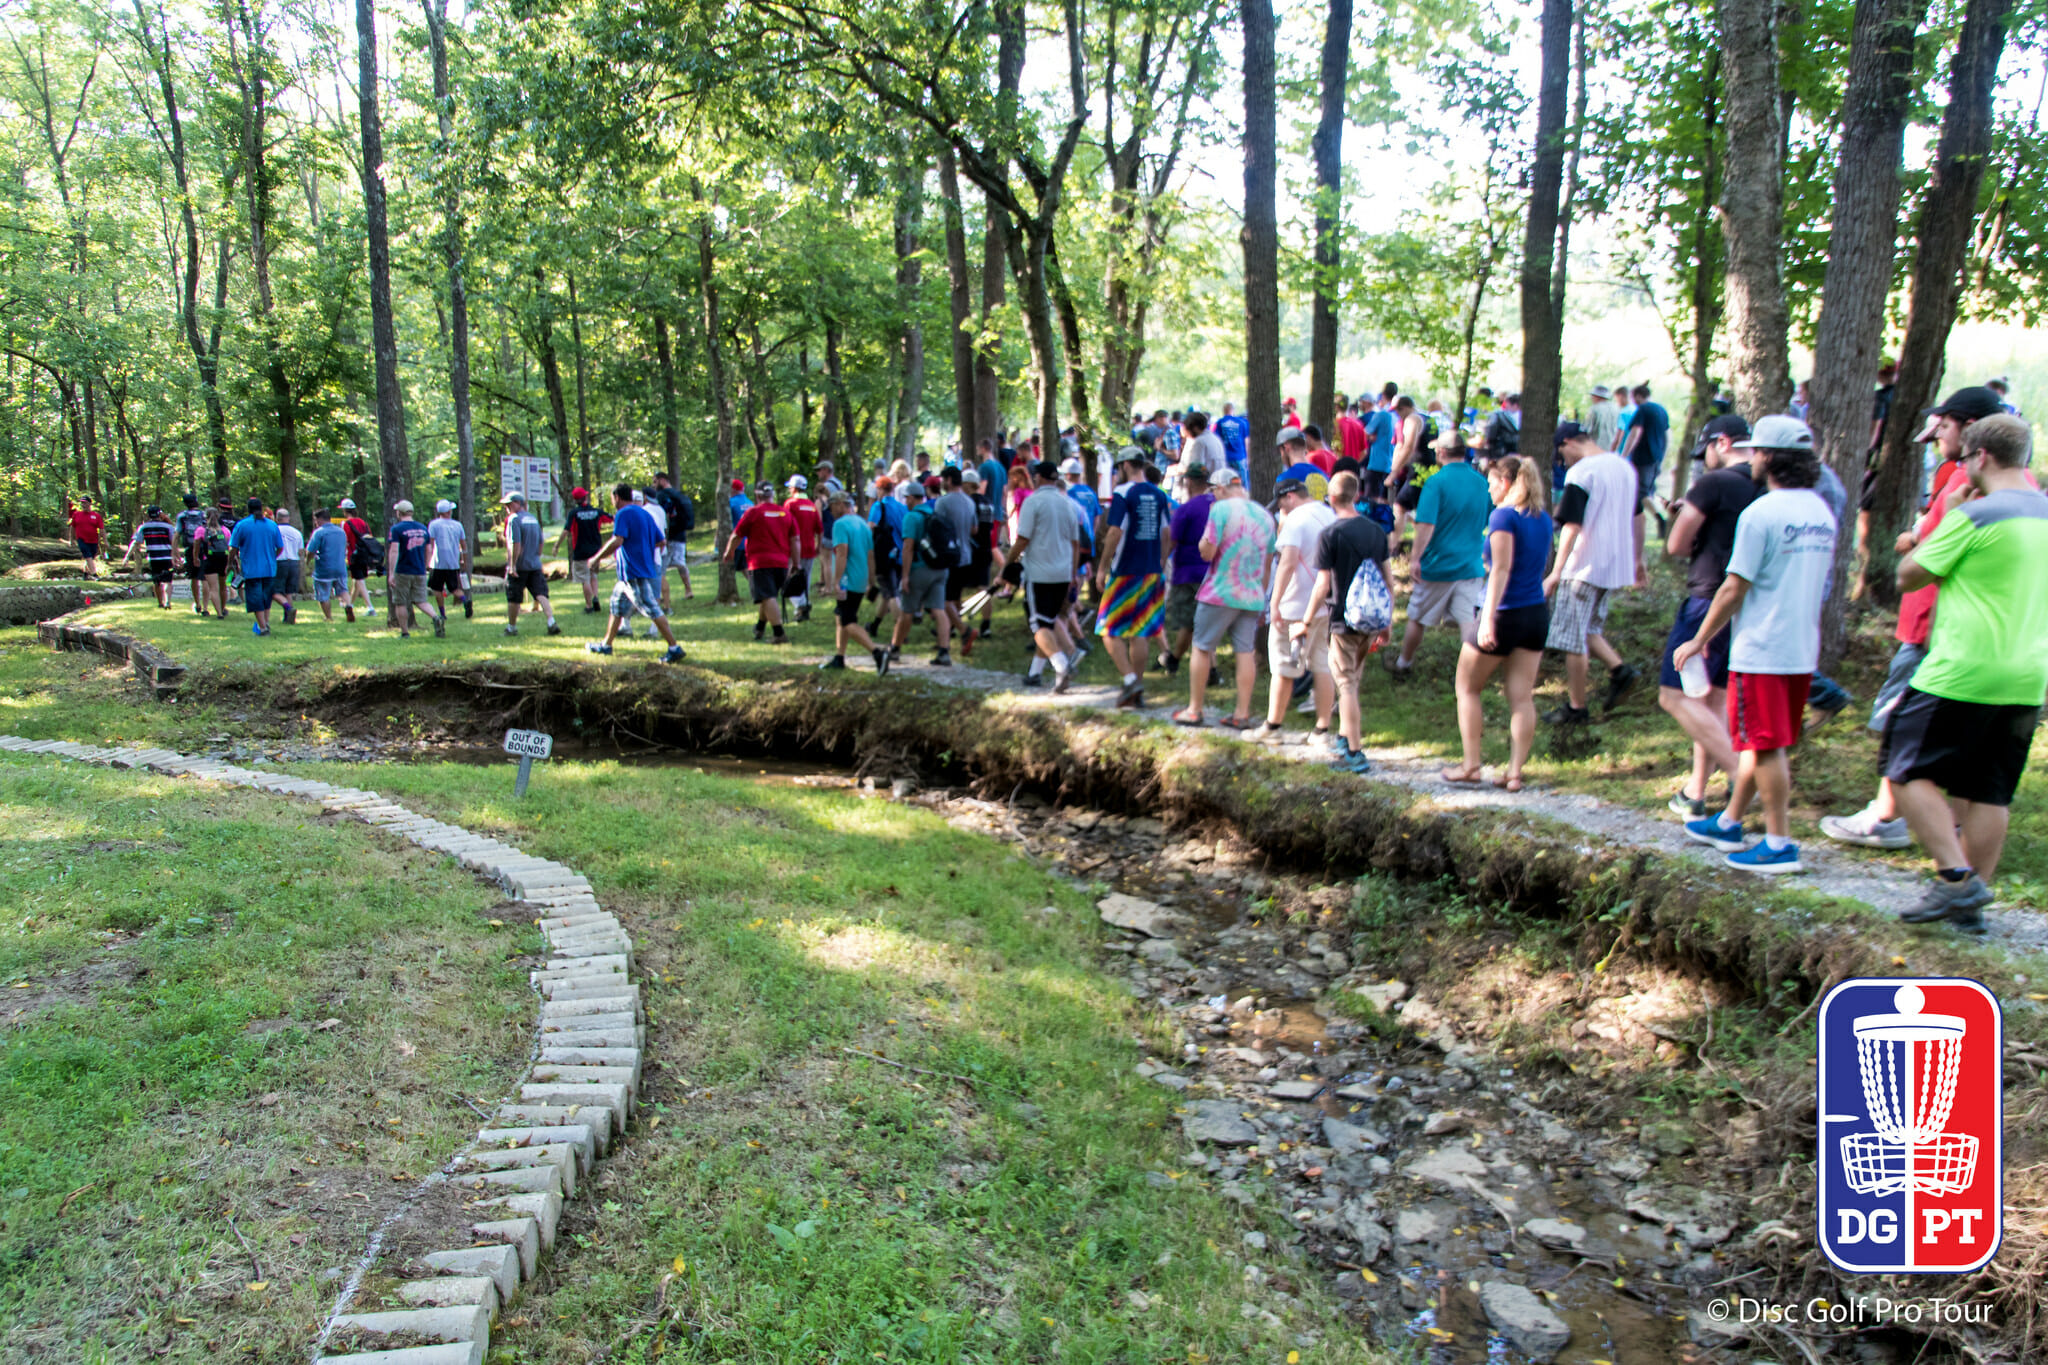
[303,763,1372,1365]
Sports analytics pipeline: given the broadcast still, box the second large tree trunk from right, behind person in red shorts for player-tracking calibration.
[1812,0,1927,669]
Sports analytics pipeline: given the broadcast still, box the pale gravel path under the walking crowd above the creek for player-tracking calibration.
[813,649,2048,952]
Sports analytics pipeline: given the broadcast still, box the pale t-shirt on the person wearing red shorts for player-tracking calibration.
[1729,489,1835,673]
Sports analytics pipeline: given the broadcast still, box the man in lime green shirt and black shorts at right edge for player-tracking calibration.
[1878,413,2048,933]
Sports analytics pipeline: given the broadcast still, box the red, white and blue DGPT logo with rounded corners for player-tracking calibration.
[1819,976,2005,1275]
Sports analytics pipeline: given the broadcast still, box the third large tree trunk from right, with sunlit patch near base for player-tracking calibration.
[1716,0,1792,420]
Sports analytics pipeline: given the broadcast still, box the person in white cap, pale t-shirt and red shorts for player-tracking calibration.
[1679,415,1837,874]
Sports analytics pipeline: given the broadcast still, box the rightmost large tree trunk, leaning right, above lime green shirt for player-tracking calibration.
[1864,0,2013,606]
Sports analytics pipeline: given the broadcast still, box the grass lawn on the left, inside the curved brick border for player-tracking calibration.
[0,755,539,1361]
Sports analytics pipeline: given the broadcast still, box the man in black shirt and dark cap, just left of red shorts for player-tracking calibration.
[1657,415,1763,821]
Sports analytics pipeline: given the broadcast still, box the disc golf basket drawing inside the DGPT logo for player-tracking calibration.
[1841,986,1978,1195]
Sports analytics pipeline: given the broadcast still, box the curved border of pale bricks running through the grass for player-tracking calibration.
[0,736,647,1365]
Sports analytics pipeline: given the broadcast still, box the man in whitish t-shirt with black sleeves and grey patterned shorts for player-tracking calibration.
[1544,422,1640,724]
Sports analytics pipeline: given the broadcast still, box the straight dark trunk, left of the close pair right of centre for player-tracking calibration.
[1239,0,1280,501]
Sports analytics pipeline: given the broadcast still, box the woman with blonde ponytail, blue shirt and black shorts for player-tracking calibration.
[1444,454,1554,792]
